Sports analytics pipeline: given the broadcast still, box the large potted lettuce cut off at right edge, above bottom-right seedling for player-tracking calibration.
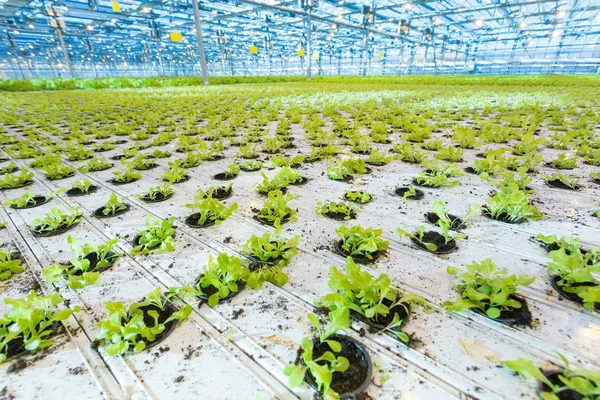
[548,247,600,309]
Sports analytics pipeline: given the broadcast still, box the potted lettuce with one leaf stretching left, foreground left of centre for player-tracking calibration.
[171,253,250,307]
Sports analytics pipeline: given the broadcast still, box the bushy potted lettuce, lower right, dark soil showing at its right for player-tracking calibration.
[442,258,535,325]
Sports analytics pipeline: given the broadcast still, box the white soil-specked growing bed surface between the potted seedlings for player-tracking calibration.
[0,95,600,399]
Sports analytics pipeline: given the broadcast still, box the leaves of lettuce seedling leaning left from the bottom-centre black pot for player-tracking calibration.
[283,308,350,399]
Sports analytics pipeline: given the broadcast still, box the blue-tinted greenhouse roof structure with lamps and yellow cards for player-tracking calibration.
[0,0,600,78]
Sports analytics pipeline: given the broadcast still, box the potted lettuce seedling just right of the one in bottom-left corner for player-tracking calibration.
[94,288,192,356]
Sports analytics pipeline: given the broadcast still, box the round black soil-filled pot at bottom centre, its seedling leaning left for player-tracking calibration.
[304,335,373,399]
